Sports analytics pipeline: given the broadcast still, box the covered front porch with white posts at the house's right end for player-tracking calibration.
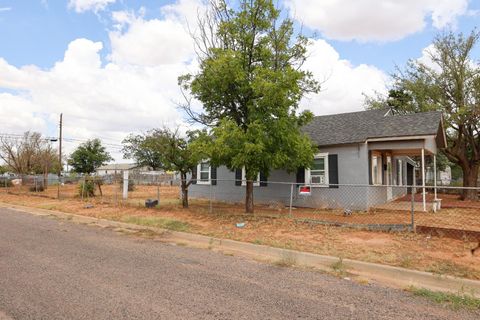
[367,136,444,212]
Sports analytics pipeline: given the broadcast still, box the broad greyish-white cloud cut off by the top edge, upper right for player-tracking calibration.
[285,0,469,41]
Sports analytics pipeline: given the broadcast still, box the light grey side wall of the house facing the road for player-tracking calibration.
[189,143,384,210]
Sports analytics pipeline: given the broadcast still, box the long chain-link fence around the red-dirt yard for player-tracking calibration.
[0,174,480,241]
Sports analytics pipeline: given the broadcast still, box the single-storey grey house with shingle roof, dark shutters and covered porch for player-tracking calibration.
[189,110,446,210]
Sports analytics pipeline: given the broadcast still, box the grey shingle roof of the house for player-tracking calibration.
[302,109,442,146]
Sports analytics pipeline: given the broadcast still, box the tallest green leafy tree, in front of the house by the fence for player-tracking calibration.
[179,0,319,213]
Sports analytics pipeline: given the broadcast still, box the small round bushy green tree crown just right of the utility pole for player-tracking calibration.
[68,139,113,174]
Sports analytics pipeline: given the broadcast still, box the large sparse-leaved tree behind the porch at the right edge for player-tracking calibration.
[367,31,480,199]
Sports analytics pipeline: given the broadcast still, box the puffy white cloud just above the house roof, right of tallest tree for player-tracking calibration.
[301,39,388,115]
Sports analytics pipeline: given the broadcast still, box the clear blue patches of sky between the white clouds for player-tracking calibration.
[0,0,480,72]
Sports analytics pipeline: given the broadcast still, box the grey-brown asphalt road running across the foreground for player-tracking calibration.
[0,209,480,320]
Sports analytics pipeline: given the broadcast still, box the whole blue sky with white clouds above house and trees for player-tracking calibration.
[0,0,480,162]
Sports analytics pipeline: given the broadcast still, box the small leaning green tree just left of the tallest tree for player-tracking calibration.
[123,128,206,208]
